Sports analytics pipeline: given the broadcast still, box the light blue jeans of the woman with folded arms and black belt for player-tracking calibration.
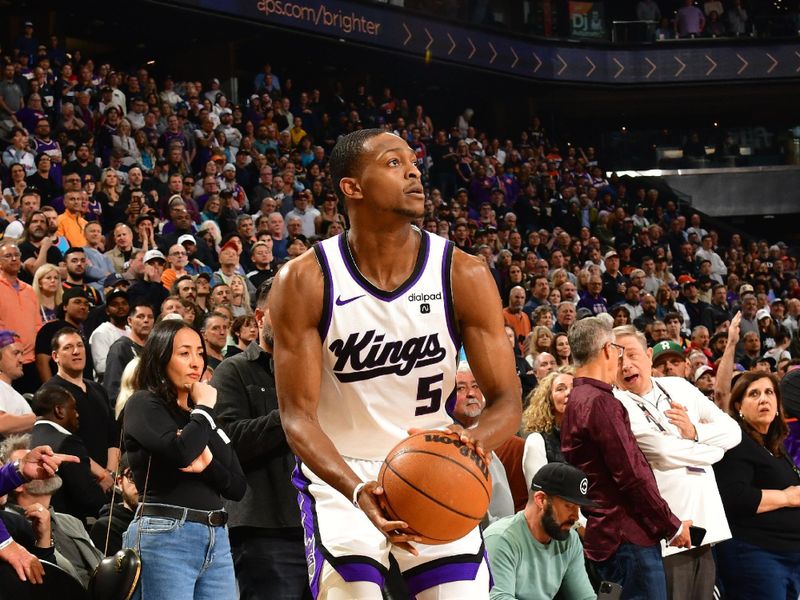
[122,504,237,600]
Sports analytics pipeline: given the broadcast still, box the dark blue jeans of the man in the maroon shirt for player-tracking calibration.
[594,544,667,600]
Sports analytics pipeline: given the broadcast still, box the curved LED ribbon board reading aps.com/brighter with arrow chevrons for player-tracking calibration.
[166,0,800,85]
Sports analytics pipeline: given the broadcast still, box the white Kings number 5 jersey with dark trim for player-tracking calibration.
[315,228,461,460]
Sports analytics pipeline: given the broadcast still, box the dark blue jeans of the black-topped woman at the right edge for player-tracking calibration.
[714,539,800,600]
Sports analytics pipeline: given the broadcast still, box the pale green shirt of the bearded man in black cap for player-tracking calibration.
[483,511,597,600]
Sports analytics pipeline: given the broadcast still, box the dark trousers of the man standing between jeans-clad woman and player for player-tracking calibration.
[231,527,311,600]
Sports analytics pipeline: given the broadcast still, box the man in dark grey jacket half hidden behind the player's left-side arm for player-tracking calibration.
[211,279,308,600]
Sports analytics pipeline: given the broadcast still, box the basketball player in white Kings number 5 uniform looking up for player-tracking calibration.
[270,129,521,600]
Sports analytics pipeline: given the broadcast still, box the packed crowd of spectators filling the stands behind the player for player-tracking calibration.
[0,16,800,597]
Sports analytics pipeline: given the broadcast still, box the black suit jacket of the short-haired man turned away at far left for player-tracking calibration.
[31,421,106,523]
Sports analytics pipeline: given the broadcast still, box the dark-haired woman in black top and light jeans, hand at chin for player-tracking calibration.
[123,320,247,600]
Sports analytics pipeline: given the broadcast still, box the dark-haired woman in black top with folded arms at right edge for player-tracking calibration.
[714,371,800,600]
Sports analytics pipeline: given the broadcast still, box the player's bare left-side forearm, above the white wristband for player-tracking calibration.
[282,415,361,498]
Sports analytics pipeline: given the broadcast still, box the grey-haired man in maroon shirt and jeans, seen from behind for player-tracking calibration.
[561,317,692,600]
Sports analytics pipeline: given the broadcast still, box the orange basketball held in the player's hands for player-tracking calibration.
[378,431,492,544]
